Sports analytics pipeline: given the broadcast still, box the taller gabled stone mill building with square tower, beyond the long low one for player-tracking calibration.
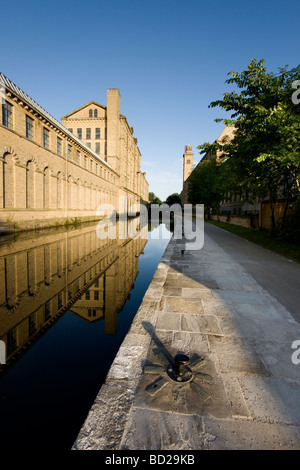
[62,88,149,211]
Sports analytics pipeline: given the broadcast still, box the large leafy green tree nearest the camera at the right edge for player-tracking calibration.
[204,59,300,228]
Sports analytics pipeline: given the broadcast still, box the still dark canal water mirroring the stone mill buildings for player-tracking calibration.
[0,218,171,450]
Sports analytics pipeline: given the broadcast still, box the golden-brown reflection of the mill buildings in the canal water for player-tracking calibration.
[0,220,148,372]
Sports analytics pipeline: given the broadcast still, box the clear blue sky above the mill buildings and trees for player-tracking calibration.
[0,0,300,200]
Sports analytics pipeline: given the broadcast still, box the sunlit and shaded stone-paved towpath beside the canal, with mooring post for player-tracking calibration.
[73,225,300,451]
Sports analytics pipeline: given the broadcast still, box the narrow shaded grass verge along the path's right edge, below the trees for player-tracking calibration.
[205,220,300,263]
